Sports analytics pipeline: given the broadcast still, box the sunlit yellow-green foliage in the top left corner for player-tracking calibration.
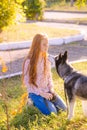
[0,0,24,31]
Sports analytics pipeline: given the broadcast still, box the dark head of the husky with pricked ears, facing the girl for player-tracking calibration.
[55,51,71,78]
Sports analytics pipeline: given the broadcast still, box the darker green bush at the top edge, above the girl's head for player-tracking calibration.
[23,0,45,20]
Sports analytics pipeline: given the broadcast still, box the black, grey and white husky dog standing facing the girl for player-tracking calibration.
[55,51,87,120]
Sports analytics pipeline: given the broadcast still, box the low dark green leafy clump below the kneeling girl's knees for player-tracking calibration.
[11,106,43,130]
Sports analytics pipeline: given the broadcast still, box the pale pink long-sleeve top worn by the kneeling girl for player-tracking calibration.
[24,58,53,95]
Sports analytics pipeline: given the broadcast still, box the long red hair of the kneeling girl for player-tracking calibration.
[22,34,48,87]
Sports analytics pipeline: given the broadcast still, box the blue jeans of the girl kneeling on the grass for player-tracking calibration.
[29,93,66,115]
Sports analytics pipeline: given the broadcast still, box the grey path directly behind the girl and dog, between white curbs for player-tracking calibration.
[0,41,87,76]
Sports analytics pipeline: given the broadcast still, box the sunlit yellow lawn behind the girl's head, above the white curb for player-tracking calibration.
[0,23,80,42]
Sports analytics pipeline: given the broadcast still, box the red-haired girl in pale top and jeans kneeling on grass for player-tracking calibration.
[23,34,66,115]
